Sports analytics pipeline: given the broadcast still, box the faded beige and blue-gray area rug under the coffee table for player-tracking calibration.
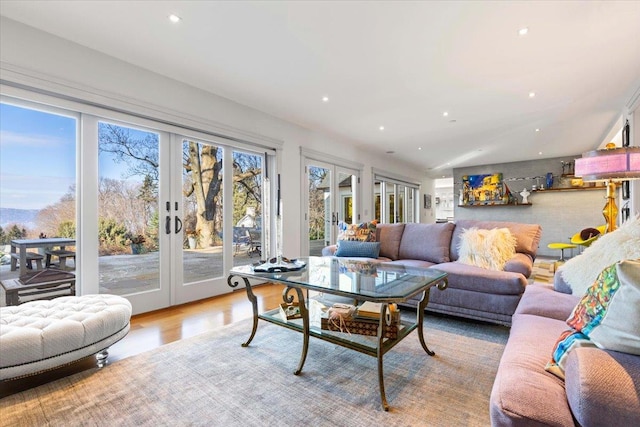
[0,316,508,427]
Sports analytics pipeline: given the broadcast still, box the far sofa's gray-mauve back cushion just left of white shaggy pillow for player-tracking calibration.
[398,223,455,263]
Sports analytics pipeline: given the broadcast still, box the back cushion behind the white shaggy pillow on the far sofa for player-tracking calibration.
[449,219,542,261]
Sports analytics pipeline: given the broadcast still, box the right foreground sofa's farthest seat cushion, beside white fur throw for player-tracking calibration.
[516,283,580,321]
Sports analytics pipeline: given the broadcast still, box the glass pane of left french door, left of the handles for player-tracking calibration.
[96,121,162,298]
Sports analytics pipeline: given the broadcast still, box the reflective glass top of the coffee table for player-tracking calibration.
[229,257,447,302]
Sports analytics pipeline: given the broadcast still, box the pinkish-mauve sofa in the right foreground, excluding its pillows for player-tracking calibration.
[490,283,640,427]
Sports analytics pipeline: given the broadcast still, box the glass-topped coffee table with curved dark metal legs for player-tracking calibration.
[227,257,447,411]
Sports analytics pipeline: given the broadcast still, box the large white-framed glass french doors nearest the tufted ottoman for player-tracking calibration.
[81,116,266,313]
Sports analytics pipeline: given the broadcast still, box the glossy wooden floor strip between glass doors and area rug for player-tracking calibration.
[0,284,283,398]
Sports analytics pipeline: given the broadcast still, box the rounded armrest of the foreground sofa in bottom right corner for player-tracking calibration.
[565,347,640,427]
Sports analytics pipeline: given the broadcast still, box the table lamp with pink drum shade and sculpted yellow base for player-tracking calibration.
[575,147,640,233]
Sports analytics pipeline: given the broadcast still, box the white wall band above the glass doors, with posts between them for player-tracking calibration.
[0,17,433,254]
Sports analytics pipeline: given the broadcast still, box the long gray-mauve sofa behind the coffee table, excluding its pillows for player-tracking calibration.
[322,220,542,325]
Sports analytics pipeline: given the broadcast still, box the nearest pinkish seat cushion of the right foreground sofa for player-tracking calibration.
[490,314,574,426]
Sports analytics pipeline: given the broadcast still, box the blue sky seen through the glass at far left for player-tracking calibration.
[0,103,134,209]
